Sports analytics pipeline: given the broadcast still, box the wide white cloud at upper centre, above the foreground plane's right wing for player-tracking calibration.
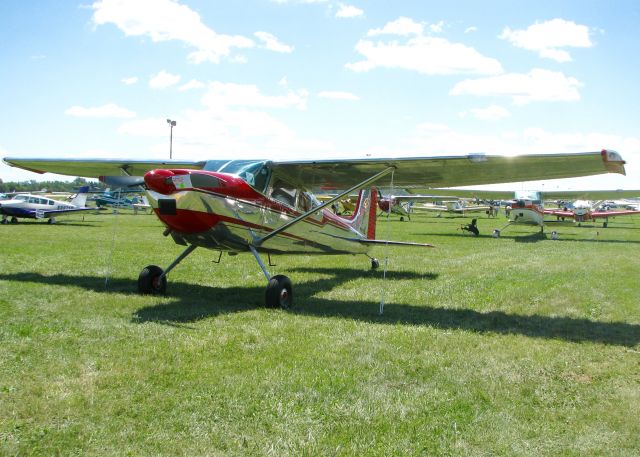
[345,35,503,75]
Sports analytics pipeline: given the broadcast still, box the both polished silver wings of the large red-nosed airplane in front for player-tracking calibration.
[4,150,625,190]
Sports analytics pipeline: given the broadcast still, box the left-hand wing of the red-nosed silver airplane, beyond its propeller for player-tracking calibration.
[4,157,206,178]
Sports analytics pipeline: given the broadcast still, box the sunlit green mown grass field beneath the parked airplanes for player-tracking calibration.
[0,211,640,456]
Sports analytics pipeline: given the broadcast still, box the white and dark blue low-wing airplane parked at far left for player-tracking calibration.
[0,186,96,224]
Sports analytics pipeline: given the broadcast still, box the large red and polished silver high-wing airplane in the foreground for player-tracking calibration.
[4,150,624,308]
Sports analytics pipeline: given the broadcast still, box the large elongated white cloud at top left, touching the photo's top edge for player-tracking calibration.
[92,0,254,63]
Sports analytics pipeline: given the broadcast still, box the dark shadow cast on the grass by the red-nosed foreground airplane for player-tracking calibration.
[0,268,640,347]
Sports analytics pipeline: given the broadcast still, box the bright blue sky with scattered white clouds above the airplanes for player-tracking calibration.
[0,0,640,189]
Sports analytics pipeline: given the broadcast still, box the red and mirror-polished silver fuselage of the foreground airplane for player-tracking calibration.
[145,166,376,254]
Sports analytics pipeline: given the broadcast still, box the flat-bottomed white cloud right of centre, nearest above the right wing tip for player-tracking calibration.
[449,68,582,105]
